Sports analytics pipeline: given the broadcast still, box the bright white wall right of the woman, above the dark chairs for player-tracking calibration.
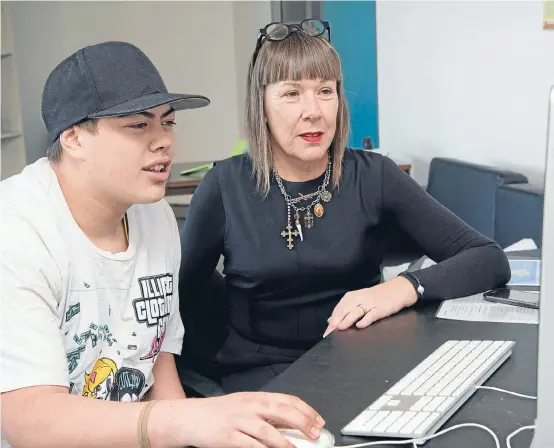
[377,1,554,182]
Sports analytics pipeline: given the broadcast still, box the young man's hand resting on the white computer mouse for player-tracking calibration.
[168,392,325,448]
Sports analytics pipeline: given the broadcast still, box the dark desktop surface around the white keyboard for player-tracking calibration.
[264,304,538,448]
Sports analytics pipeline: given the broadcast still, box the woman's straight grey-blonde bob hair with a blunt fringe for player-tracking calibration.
[245,32,350,196]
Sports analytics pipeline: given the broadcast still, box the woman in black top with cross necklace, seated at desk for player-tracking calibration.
[180,21,510,392]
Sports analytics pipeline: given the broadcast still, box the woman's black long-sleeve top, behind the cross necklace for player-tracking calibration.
[179,150,510,368]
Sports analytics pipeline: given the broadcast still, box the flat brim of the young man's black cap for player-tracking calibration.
[88,93,210,118]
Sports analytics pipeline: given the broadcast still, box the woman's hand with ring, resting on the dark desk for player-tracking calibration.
[323,277,417,337]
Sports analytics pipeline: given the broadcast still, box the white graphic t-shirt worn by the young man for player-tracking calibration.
[0,158,184,401]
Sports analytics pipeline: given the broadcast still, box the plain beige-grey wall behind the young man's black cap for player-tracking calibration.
[10,1,246,163]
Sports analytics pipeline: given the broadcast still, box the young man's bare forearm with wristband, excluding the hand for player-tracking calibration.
[1,386,185,448]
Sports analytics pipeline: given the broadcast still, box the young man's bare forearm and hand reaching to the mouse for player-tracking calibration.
[1,386,324,448]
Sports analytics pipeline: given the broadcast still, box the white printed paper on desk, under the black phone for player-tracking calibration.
[437,294,539,325]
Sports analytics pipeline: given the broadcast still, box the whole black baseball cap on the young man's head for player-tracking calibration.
[42,42,210,143]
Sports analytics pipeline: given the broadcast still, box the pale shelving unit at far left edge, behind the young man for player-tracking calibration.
[0,2,26,180]
